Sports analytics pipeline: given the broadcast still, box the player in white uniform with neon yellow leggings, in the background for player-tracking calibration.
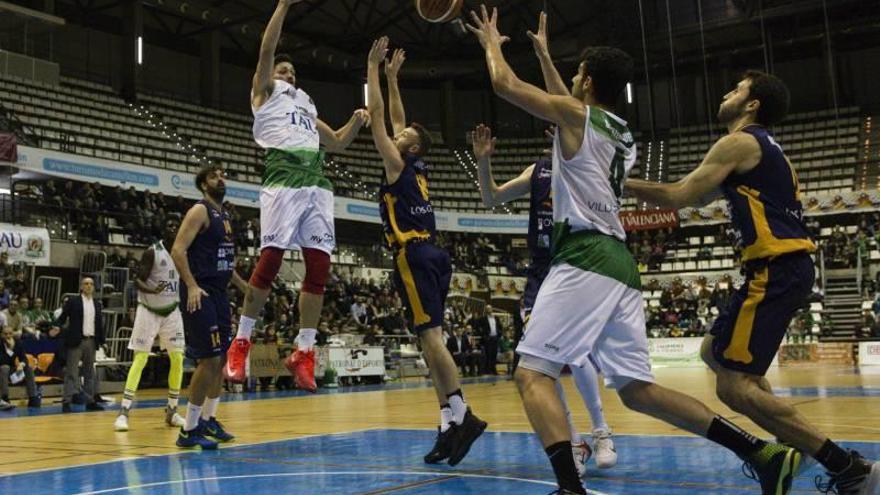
[113,217,185,431]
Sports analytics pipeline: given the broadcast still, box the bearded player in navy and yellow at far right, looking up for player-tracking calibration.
[626,71,880,495]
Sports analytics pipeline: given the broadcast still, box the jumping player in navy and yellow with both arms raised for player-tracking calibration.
[367,37,486,466]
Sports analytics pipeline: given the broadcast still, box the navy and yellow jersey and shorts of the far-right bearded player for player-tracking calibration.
[712,125,816,375]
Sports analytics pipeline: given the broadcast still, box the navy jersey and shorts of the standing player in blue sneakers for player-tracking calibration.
[180,200,235,359]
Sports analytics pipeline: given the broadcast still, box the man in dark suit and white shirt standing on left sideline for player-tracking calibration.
[52,277,104,412]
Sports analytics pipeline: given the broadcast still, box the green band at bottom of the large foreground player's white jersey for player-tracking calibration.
[552,220,642,290]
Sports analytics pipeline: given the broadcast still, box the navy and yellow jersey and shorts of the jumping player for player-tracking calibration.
[379,154,452,332]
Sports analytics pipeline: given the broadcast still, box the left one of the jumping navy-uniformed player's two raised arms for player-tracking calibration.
[367,36,404,184]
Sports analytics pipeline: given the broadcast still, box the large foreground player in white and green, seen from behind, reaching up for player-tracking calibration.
[468,6,800,495]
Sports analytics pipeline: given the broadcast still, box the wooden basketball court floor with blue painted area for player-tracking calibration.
[0,366,880,495]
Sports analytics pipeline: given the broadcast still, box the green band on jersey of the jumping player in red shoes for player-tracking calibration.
[262,148,333,191]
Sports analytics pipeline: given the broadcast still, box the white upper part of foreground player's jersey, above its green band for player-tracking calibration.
[551,106,636,241]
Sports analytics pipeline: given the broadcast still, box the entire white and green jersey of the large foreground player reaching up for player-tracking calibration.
[551,106,641,289]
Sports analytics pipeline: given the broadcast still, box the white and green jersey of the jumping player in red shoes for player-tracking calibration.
[251,79,333,190]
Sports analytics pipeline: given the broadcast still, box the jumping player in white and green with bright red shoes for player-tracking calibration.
[223,0,369,392]
